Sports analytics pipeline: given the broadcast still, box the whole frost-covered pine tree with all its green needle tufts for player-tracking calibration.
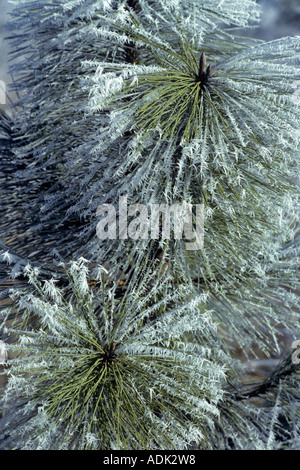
[0,0,300,450]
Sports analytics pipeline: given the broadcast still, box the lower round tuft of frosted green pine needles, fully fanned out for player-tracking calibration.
[2,260,226,450]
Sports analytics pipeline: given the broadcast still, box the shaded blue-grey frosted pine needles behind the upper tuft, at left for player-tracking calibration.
[0,1,257,260]
